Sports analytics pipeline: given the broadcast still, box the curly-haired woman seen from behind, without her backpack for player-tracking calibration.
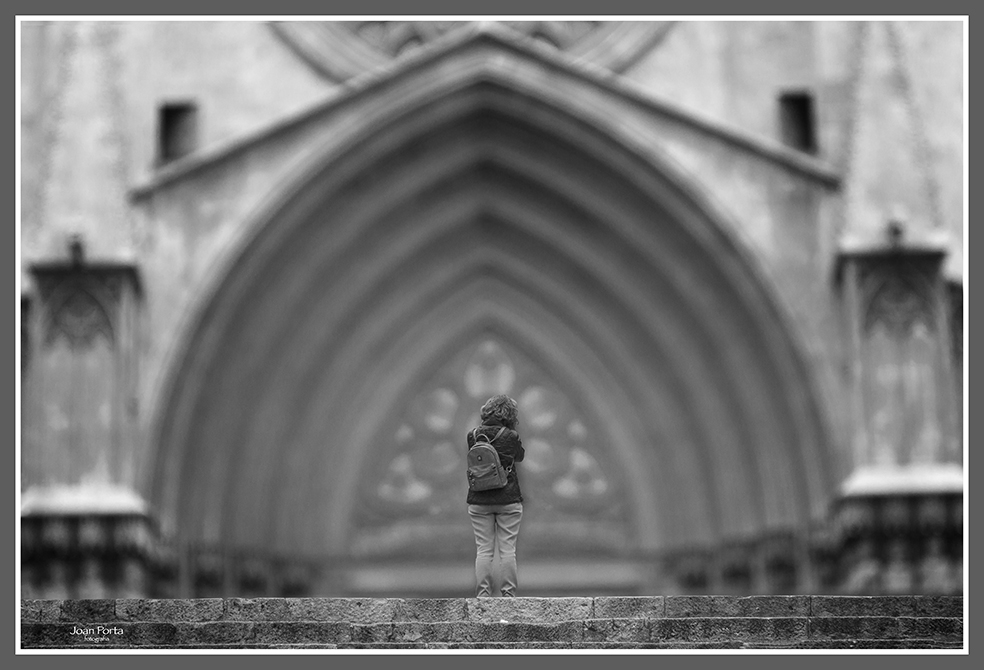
[467,395,526,598]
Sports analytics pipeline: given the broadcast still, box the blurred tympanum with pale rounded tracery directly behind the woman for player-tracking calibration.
[358,339,625,556]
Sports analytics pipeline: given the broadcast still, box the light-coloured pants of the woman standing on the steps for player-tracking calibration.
[468,503,523,598]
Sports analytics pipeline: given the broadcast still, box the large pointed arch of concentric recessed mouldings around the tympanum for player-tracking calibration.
[150,68,832,576]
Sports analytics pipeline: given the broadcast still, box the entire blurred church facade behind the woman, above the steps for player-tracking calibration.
[19,20,966,598]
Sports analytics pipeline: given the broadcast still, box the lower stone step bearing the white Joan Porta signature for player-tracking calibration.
[21,617,963,648]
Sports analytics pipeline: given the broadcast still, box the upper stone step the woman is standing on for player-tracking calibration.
[21,596,963,624]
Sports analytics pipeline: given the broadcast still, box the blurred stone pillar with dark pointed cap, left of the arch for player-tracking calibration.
[21,233,153,598]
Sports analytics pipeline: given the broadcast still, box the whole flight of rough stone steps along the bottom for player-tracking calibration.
[20,596,963,650]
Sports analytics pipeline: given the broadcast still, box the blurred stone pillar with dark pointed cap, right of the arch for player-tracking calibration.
[834,214,963,594]
